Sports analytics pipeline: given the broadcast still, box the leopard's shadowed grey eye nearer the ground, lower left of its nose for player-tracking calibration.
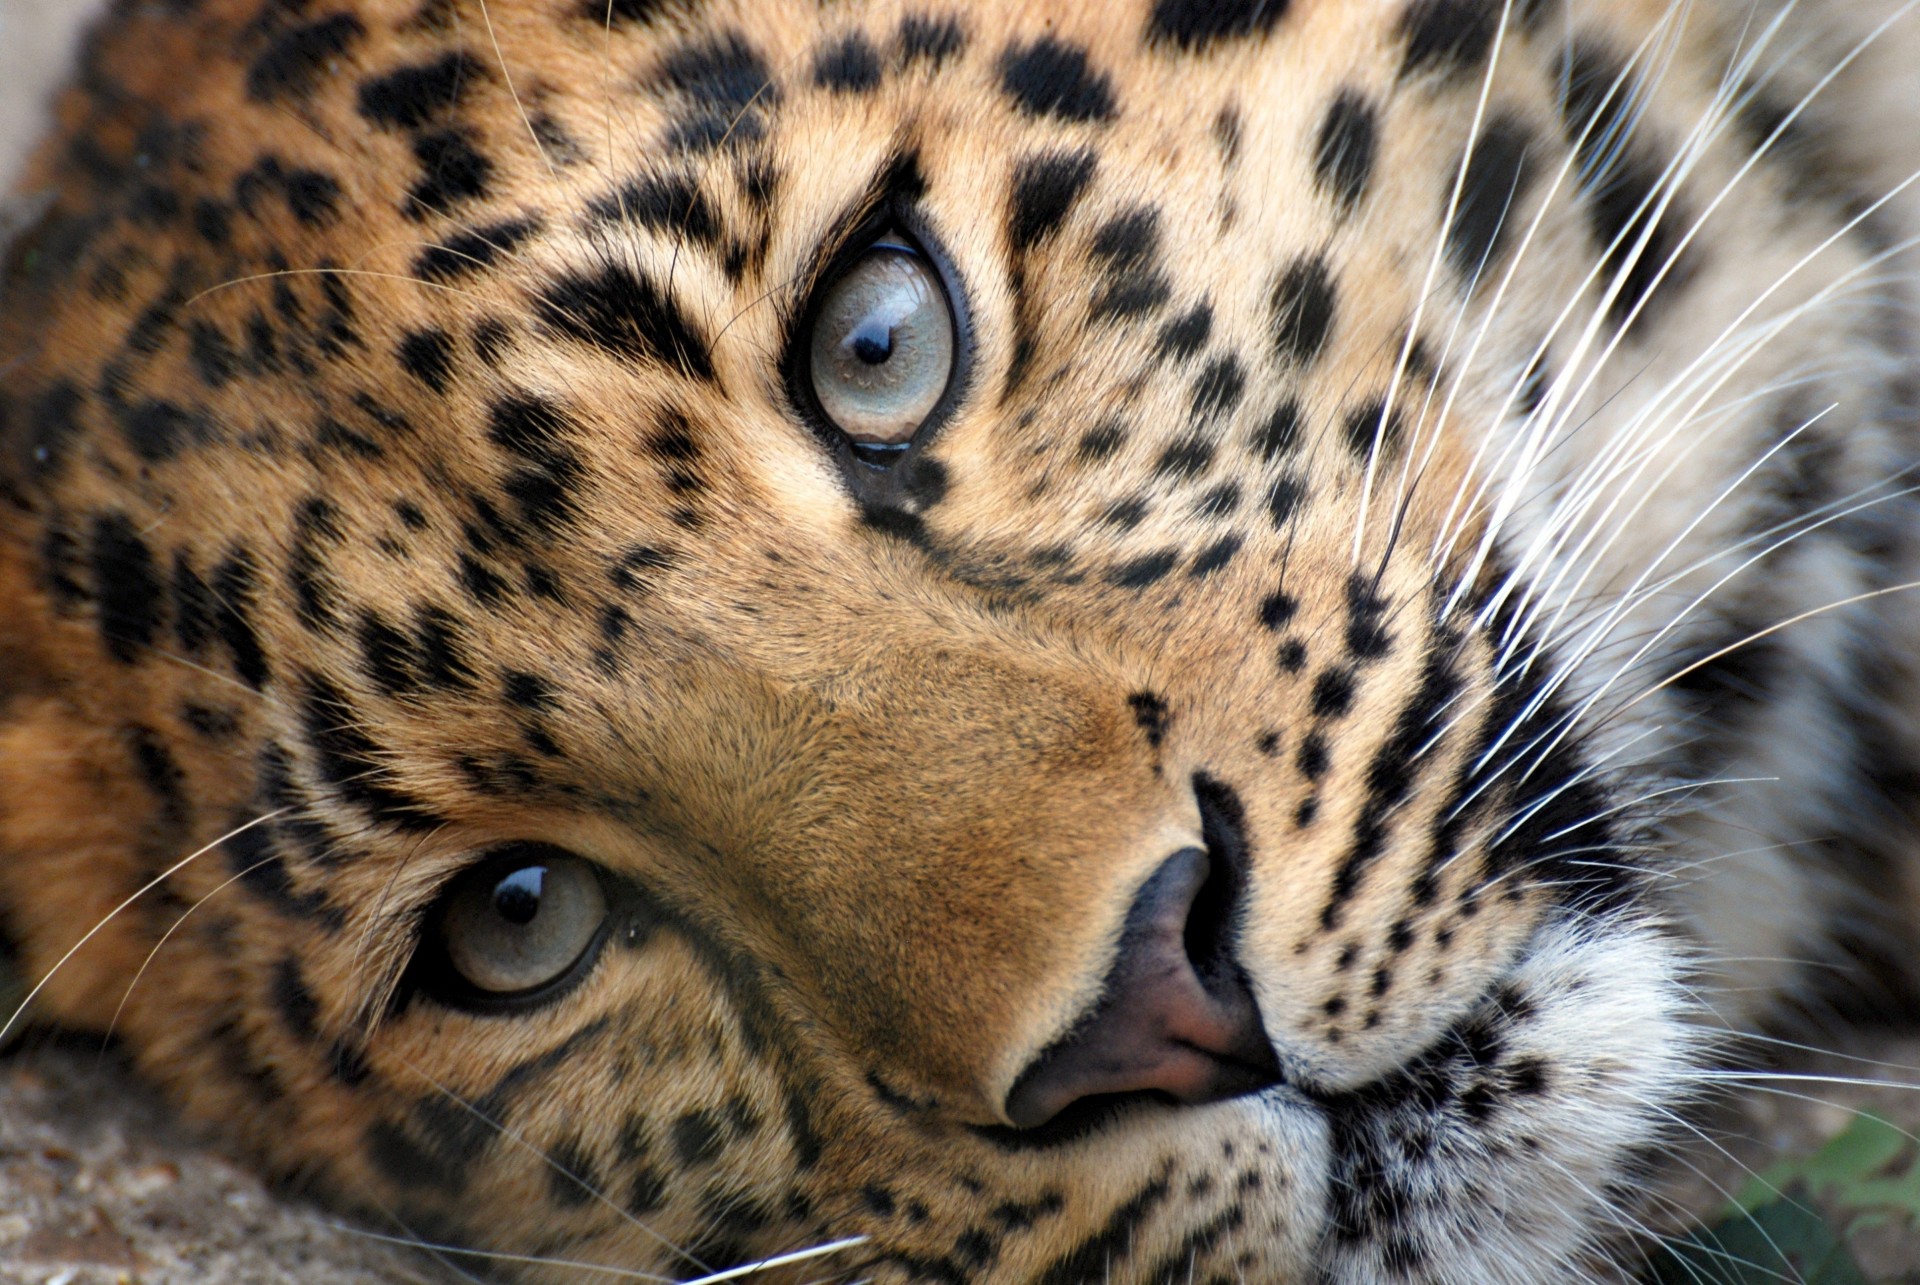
[436,843,607,999]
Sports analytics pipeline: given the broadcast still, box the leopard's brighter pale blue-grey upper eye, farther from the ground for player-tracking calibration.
[808,242,954,448]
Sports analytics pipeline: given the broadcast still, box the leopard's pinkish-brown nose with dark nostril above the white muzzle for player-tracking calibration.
[1006,847,1281,1129]
